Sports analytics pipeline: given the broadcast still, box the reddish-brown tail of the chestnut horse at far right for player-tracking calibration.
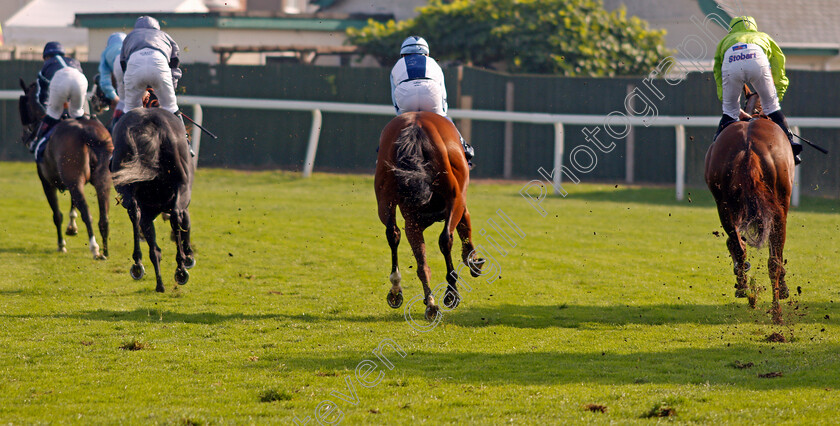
[734,142,776,248]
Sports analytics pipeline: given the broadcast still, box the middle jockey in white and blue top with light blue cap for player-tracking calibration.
[391,36,475,161]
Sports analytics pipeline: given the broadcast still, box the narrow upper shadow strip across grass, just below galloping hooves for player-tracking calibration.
[0,302,840,329]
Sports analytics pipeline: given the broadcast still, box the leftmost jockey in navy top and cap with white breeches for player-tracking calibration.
[29,41,87,152]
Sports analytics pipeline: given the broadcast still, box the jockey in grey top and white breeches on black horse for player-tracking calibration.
[120,16,181,115]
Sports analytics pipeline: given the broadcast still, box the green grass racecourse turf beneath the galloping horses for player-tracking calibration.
[0,163,840,424]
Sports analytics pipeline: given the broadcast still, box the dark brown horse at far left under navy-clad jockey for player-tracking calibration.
[19,79,114,259]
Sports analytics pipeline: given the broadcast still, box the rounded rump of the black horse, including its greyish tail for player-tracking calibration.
[112,108,186,186]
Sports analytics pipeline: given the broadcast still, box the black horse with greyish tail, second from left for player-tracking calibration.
[111,108,195,292]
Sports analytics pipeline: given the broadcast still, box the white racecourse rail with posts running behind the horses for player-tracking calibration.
[0,90,840,206]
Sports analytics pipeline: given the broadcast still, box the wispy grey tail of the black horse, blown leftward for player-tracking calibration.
[111,111,167,186]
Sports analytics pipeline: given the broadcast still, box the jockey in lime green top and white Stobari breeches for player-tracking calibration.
[715,16,802,164]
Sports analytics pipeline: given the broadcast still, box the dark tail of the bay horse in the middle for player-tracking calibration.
[391,123,434,206]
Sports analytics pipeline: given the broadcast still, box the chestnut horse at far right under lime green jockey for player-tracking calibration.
[706,86,795,323]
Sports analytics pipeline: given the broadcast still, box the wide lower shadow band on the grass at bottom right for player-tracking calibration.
[278,342,840,392]
